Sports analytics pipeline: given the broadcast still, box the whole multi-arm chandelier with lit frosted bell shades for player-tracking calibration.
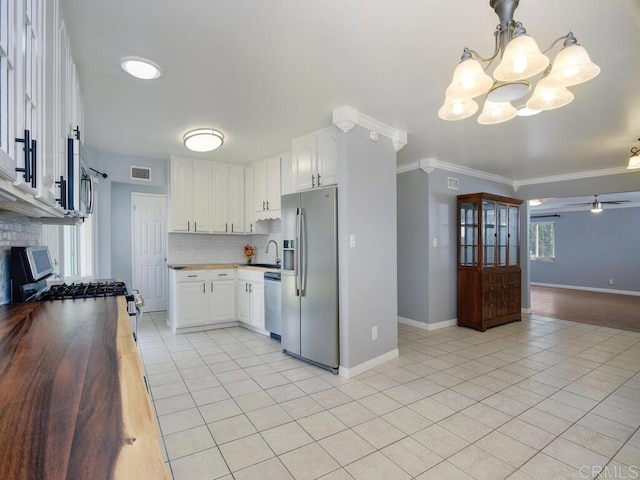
[438,0,600,125]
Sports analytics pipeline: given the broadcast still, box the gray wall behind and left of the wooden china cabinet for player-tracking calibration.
[397,169,516,323]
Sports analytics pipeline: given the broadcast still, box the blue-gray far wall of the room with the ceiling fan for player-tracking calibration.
[531,208,640,292]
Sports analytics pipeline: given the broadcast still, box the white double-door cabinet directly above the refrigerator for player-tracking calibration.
[291,127,338,191]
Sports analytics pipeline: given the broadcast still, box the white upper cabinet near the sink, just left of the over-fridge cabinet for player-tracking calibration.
[253,155,281,220]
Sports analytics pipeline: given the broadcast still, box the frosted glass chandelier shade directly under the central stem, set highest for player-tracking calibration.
[493,35,549,82]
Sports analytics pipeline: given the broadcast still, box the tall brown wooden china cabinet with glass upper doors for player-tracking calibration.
[458,193,522,332]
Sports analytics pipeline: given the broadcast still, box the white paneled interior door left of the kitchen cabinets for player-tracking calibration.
[131,193,167,312]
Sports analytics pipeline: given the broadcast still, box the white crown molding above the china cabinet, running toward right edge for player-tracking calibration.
[396,158,629,191]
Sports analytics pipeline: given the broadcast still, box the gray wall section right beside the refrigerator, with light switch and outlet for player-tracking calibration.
[338,126,398,368]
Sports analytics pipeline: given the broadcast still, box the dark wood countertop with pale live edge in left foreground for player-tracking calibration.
[0,297,169,480]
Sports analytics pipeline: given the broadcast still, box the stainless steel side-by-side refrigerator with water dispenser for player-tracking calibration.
[281,188,340,372]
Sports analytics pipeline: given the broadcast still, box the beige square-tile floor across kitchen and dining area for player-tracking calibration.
[139,312,640,480]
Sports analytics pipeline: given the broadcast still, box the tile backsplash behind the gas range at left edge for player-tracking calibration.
[0,214,42,304]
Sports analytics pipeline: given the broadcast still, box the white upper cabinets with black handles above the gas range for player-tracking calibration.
[0,0,76,217]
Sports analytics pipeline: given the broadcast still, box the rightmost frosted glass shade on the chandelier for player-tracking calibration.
[547,44,600,87]
